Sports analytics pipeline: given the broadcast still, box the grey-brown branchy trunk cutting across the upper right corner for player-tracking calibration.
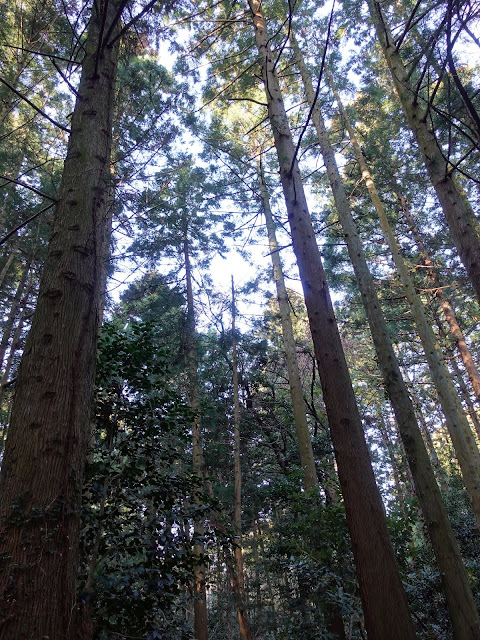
[368,0,480,300]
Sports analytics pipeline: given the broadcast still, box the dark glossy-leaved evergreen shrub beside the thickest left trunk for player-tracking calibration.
[80,321,205,640]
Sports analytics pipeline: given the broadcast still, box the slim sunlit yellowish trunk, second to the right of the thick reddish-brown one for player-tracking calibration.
[330,62,480,527]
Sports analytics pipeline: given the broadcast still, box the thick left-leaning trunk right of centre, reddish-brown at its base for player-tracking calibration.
[249,5,415,640]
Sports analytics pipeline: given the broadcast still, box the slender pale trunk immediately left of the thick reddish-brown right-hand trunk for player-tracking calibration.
[258,155,318,489]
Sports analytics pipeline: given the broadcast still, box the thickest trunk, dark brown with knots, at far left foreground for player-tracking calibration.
[0,1,118,640]
